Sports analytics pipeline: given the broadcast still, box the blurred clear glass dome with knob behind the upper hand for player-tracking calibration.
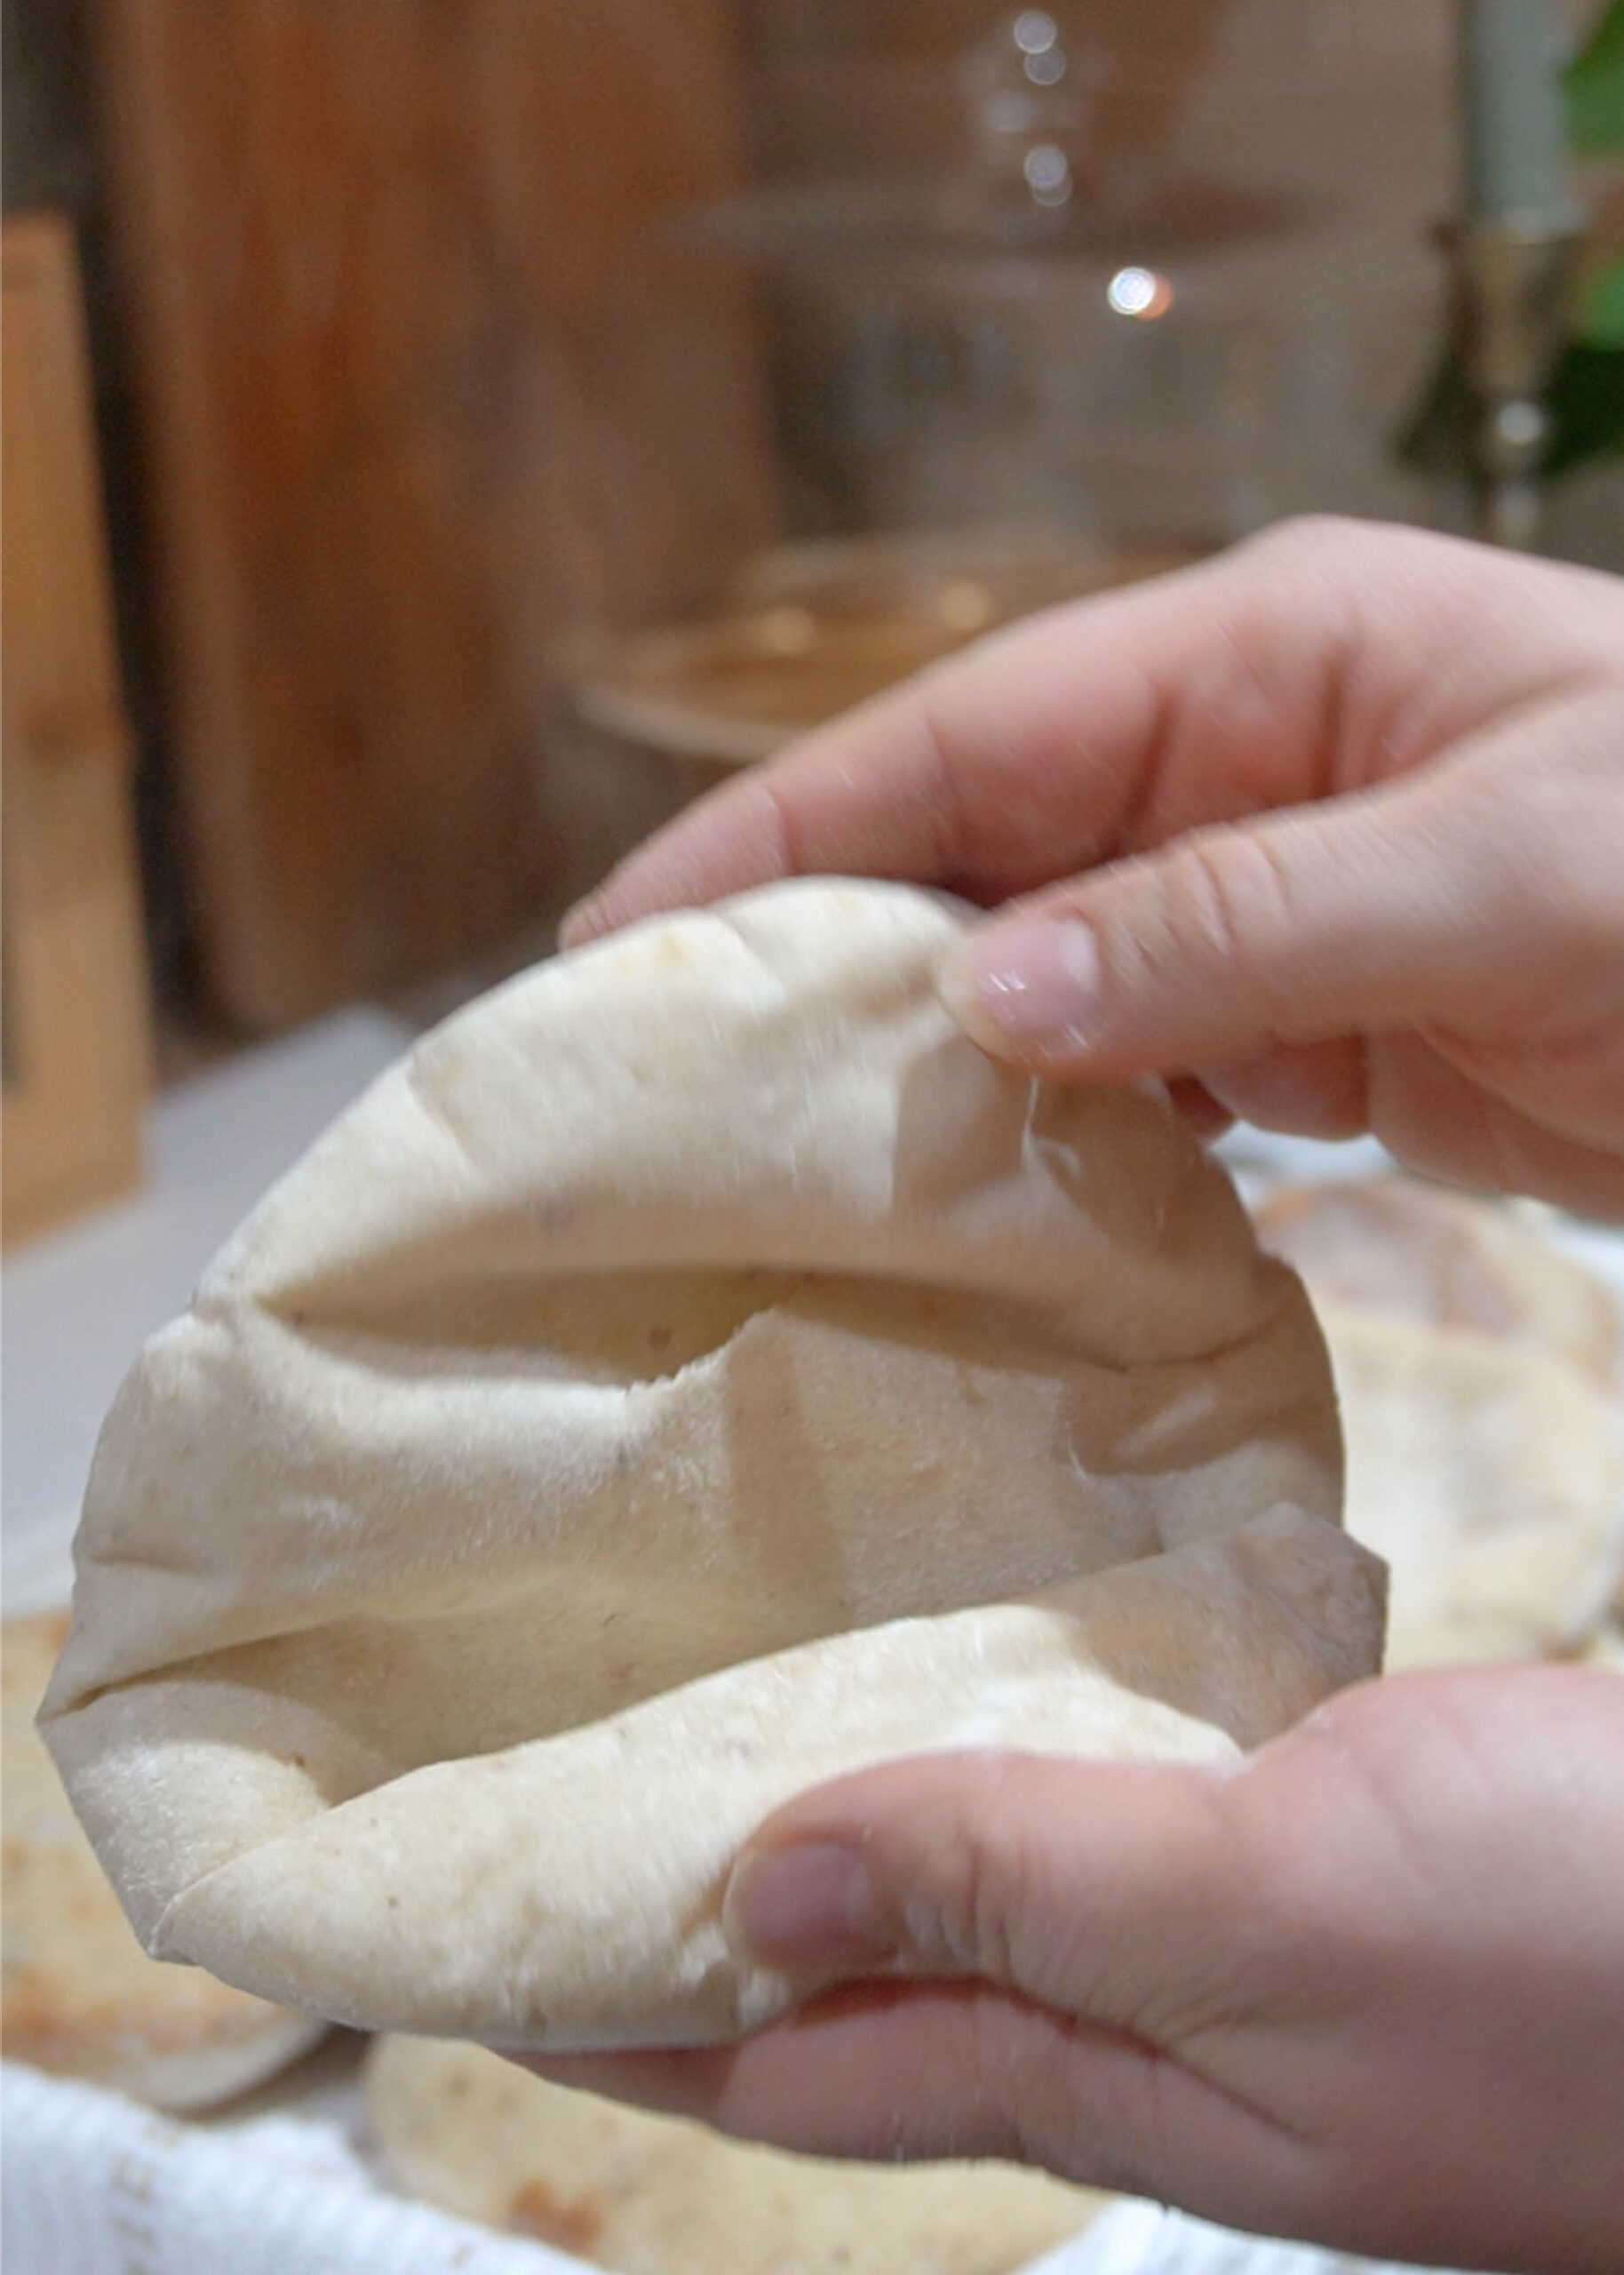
[577,7,1437,767]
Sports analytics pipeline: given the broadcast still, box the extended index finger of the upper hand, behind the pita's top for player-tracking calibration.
[564,523,1515,946]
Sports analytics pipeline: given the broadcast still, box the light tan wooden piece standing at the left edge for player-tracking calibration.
[0,219,147,1242]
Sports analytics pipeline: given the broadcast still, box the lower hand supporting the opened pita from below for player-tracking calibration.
[537,1667,1624,2275]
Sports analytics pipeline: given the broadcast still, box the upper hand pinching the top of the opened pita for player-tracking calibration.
[566,521,1624,1215]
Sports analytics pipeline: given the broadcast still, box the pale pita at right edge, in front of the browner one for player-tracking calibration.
[1321,1304,1624,1667]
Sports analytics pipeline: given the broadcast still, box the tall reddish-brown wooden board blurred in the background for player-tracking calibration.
[100,0,764,1028]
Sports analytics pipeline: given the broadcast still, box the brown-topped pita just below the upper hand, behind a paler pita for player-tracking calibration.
[1255,1177,1620,1383]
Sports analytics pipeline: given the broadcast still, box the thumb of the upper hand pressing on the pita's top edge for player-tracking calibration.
[942,783,1537,1078]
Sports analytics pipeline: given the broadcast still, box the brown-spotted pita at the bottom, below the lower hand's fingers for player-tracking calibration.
[366,2039,1108,2275]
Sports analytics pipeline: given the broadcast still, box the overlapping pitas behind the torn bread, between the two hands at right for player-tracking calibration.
[1258,1177,1624,1667]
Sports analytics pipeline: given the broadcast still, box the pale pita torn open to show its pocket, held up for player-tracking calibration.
[45,882,1381,2048]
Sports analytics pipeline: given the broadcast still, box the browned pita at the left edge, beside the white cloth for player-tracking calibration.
[0,1613,323,2109]
